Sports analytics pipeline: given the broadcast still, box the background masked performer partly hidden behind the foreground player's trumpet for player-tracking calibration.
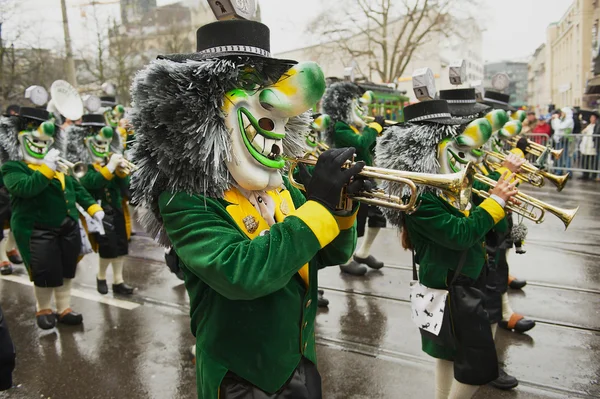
[322,82,385,276]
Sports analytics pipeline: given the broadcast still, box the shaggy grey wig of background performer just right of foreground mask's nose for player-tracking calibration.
[321,82,364,144]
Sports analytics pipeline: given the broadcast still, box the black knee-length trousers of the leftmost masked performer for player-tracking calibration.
[29,216,81,287]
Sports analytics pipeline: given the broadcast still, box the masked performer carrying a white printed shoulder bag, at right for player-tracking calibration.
[377,100,516,399]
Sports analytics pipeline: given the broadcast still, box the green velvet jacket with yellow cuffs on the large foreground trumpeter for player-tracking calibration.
[159,181,356,399]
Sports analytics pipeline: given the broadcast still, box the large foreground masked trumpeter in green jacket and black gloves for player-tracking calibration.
[132,20,363,399]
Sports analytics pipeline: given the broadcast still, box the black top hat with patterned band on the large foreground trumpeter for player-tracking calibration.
[158,19,297,65]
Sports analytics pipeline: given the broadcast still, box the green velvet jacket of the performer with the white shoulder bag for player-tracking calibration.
[405,193,504,360]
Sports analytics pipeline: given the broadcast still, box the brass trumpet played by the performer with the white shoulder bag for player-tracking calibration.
[473,173,579,230]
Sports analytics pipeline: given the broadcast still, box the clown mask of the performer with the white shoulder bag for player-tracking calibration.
[438,118,492,173]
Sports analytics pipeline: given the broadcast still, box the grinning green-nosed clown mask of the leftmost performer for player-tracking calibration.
[19,121,56,165]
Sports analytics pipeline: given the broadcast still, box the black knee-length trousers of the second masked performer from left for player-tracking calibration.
[96,206,129,259]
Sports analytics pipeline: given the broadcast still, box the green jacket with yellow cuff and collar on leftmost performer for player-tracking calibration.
[2,161,102,268]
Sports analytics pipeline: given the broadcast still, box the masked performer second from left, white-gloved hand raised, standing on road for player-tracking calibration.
[67,114,133,295]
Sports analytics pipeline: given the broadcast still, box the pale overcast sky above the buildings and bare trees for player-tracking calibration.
[3,0,571,61]
